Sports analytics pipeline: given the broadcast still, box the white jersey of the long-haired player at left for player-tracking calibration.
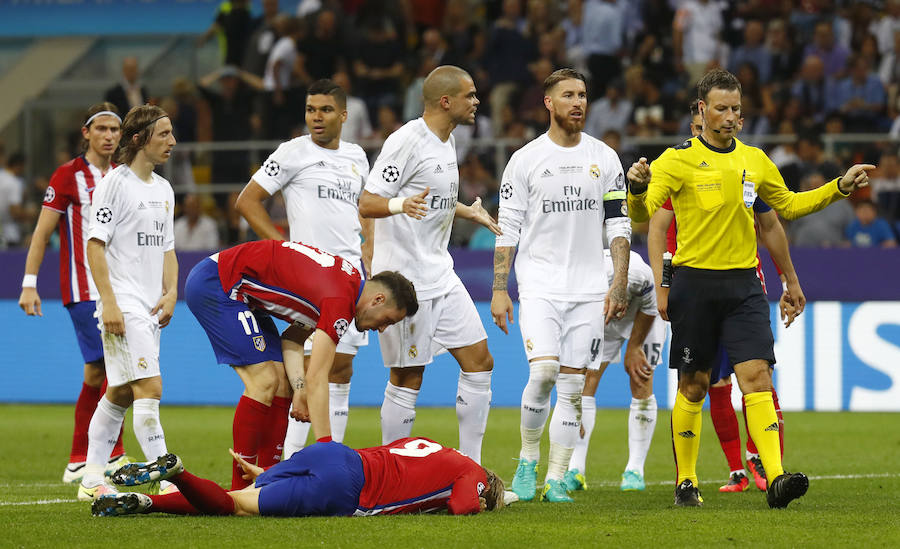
[89,164,175,313]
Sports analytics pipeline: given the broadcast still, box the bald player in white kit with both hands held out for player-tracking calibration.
[359,65,500,463]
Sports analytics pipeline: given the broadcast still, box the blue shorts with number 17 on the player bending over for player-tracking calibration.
[184,258,282,366]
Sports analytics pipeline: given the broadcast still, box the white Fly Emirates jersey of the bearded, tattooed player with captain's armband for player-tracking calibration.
[500,133,625,301]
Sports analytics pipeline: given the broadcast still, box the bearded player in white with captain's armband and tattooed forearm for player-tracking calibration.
[491,69,631,502]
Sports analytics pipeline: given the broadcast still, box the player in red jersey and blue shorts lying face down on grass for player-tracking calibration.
[91,437,504,517]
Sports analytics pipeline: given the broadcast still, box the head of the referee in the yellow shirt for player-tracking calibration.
[697,69,742,148]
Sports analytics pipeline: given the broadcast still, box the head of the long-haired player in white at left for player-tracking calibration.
[116,105,175,166]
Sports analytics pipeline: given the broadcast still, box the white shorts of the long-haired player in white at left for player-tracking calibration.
[97,305,160,387]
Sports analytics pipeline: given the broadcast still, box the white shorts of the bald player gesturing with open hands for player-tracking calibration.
[378,280,487,368]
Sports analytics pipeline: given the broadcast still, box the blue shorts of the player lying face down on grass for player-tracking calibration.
[255,442,366,517]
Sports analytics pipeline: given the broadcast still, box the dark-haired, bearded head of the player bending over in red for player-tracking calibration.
[356,271,419,332]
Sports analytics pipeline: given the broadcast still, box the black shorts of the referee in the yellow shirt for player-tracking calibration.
[669,267,775,372]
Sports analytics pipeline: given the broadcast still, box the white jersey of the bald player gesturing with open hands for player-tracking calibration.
[366,118,459,300]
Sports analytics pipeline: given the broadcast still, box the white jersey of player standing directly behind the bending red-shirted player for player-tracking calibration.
[253,135,369,272]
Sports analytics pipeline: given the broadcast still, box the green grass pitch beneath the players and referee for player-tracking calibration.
[0,405,900,549]
